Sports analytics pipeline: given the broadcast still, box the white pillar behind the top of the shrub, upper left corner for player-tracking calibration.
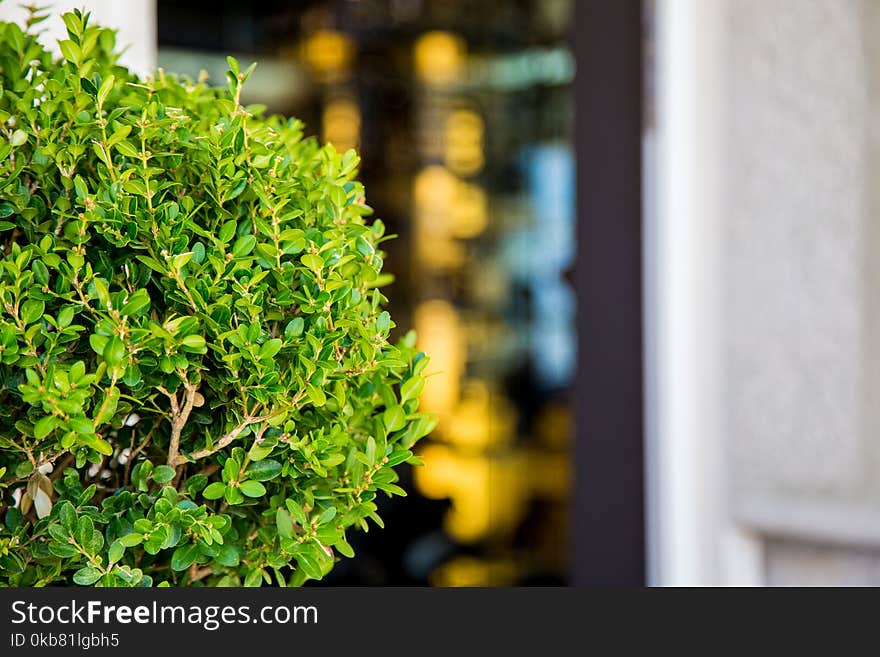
[0,0,157,75]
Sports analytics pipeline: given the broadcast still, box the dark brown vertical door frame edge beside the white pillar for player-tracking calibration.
[571,0,646,586]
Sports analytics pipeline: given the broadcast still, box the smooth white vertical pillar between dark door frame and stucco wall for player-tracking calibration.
[645,0,760,585]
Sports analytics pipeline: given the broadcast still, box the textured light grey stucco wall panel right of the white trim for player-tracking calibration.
[719,0,880,581]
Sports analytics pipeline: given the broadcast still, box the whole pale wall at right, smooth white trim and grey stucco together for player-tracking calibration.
[645,0,880,585]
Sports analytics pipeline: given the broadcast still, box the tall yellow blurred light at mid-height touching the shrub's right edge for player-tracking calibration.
[414,299,467,420]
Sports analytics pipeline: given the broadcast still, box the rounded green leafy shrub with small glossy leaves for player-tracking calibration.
[0,12,436,586]
